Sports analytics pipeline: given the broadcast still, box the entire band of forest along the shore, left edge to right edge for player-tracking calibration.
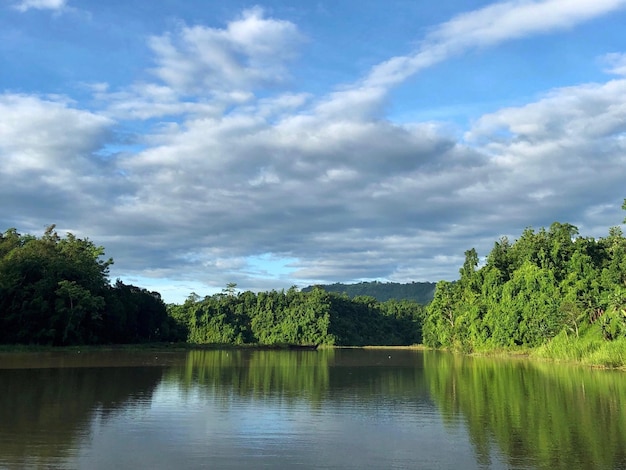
[0,200,626,366]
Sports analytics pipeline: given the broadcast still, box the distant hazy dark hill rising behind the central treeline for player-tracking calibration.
[302,281,436,305]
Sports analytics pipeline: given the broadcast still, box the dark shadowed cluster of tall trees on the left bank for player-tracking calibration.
[0,226,174,345]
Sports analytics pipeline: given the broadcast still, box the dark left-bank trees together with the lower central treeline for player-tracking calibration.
[0,226,424,345]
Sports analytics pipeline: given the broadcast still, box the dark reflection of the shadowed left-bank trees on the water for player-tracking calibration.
[0,367,162,468]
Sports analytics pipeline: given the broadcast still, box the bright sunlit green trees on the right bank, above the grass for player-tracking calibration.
[423,201,626,351]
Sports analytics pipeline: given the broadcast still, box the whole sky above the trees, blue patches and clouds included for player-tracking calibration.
[0,0,626,303]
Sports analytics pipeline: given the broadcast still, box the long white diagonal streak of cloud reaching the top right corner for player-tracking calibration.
[316,0,626,125]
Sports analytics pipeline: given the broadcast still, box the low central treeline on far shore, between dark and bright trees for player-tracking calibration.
[169,287,423,346]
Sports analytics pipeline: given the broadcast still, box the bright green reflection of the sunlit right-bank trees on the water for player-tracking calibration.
[424,352,626,469]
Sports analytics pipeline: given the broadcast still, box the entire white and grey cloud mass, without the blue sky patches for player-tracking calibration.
[0,0,626,302]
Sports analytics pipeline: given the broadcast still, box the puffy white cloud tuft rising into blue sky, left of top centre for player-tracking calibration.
[150,7,302,95]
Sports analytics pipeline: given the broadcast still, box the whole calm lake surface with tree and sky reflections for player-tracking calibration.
[0,349,626,470]
